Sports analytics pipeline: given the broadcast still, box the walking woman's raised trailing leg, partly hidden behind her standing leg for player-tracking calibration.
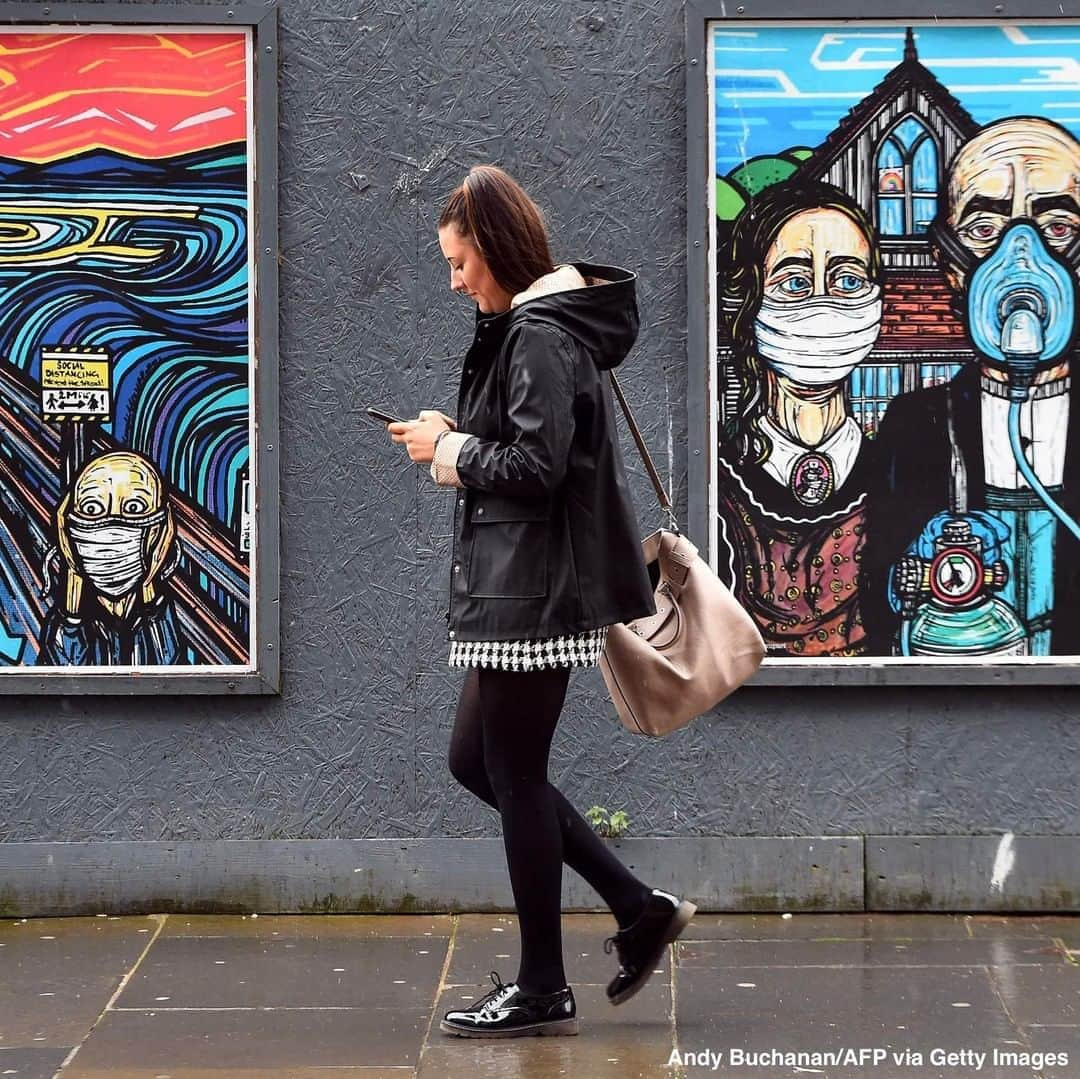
[449,667,650,929]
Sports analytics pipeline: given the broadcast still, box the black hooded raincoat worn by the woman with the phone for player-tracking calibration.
[446,262,656,640]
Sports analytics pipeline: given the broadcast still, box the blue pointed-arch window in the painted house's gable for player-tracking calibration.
[877,116,939,237]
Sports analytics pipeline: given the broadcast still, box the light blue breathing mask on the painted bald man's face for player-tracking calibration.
[967,219,1077,389]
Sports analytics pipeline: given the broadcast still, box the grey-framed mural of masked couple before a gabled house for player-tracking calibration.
[687,2,1080,684]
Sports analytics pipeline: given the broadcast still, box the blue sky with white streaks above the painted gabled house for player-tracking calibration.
[712,25,1080,168]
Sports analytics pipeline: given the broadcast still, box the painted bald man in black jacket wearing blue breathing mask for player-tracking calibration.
[862,117,1080,657]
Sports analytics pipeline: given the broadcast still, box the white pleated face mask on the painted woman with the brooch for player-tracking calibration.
[754,285,881,386]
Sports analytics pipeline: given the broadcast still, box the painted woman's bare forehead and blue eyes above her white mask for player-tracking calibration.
[764,208,872,304]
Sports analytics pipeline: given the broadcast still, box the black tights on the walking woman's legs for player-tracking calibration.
[449,667,650,993]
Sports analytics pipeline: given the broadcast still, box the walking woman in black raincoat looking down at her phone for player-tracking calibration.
[389,165,696,1038]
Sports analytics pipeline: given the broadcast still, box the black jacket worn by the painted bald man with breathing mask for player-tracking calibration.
[861,363,1080,656]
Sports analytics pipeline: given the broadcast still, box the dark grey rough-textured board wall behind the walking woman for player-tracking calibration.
[0,0,1080,911]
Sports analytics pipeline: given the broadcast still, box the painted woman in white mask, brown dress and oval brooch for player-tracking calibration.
[718,181,881,656]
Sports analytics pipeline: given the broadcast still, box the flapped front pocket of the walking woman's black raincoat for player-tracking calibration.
[469,494,551,599]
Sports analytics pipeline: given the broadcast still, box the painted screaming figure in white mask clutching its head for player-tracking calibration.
[38,451,187,666]
